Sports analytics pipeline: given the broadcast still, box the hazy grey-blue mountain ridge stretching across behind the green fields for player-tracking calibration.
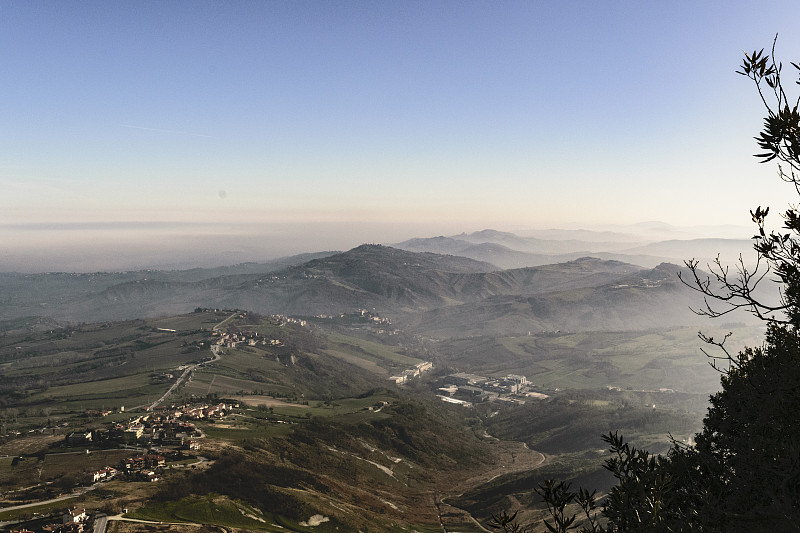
[0,237,740,337]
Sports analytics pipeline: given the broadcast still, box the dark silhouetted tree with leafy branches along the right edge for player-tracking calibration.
[493,42,800,533]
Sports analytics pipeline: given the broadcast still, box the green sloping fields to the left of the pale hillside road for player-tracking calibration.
[0,313,230,414]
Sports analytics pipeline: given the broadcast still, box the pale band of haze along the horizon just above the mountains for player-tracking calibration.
[0,218,751,273]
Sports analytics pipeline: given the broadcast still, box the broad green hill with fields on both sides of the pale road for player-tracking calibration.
[0,312,432,434]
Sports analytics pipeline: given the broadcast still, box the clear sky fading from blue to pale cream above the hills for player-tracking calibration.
[0,0,800,270]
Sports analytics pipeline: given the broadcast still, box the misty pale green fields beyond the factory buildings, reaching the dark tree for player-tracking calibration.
[443,327,762,395]
